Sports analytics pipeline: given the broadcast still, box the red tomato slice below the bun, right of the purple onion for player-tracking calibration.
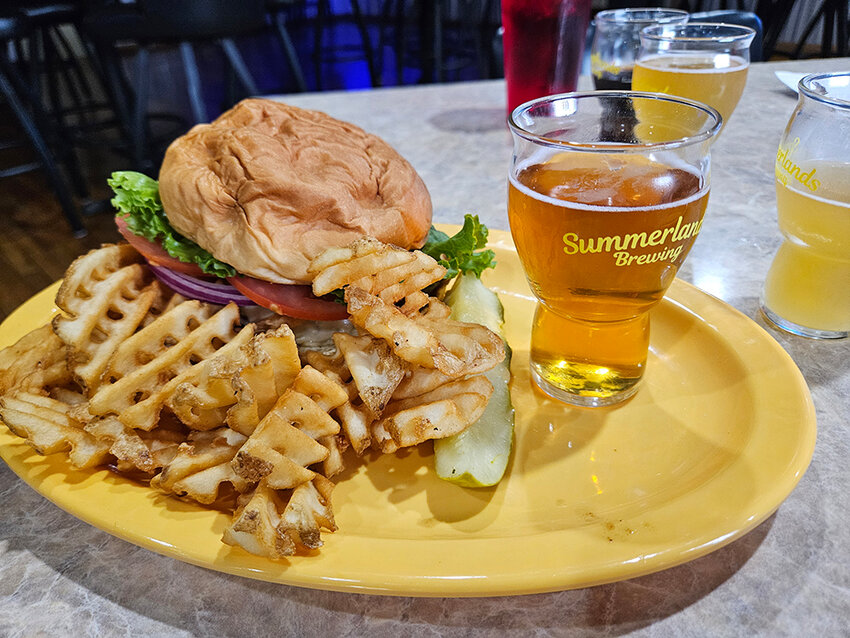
[227,276,348,321]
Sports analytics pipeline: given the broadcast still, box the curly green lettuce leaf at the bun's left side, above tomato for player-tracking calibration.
[107,171,236,278]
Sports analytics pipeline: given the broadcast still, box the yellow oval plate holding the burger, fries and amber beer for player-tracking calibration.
[0,232,816,596]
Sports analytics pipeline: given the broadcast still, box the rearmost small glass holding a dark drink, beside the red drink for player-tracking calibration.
[590,8,688,91]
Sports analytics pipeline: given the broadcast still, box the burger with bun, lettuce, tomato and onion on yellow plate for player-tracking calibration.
[109,99,494,321]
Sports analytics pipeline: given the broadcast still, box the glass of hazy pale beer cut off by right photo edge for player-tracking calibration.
[761,72,850,339]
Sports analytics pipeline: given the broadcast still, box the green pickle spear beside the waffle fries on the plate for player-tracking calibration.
[434,274,514,487]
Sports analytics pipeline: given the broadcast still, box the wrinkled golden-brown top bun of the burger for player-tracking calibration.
[159,99,431,283]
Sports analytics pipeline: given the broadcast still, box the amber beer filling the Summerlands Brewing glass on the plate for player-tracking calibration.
[508,153,708,398]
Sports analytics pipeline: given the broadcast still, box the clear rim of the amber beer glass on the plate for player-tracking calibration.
[508,91,723,153]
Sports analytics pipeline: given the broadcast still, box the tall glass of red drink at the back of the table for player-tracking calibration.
[502,0,591,113]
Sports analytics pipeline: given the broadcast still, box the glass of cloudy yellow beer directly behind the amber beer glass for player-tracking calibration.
[632,22,756,129]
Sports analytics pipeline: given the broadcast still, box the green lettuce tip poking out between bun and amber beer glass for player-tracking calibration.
[422,214,496,279]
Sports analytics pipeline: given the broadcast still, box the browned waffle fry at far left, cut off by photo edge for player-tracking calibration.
[0,324,71,395]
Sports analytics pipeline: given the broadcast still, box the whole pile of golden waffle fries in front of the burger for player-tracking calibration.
[0,232,504,558]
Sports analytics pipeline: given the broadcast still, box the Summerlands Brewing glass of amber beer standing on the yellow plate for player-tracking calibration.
[508,91,721,407]
